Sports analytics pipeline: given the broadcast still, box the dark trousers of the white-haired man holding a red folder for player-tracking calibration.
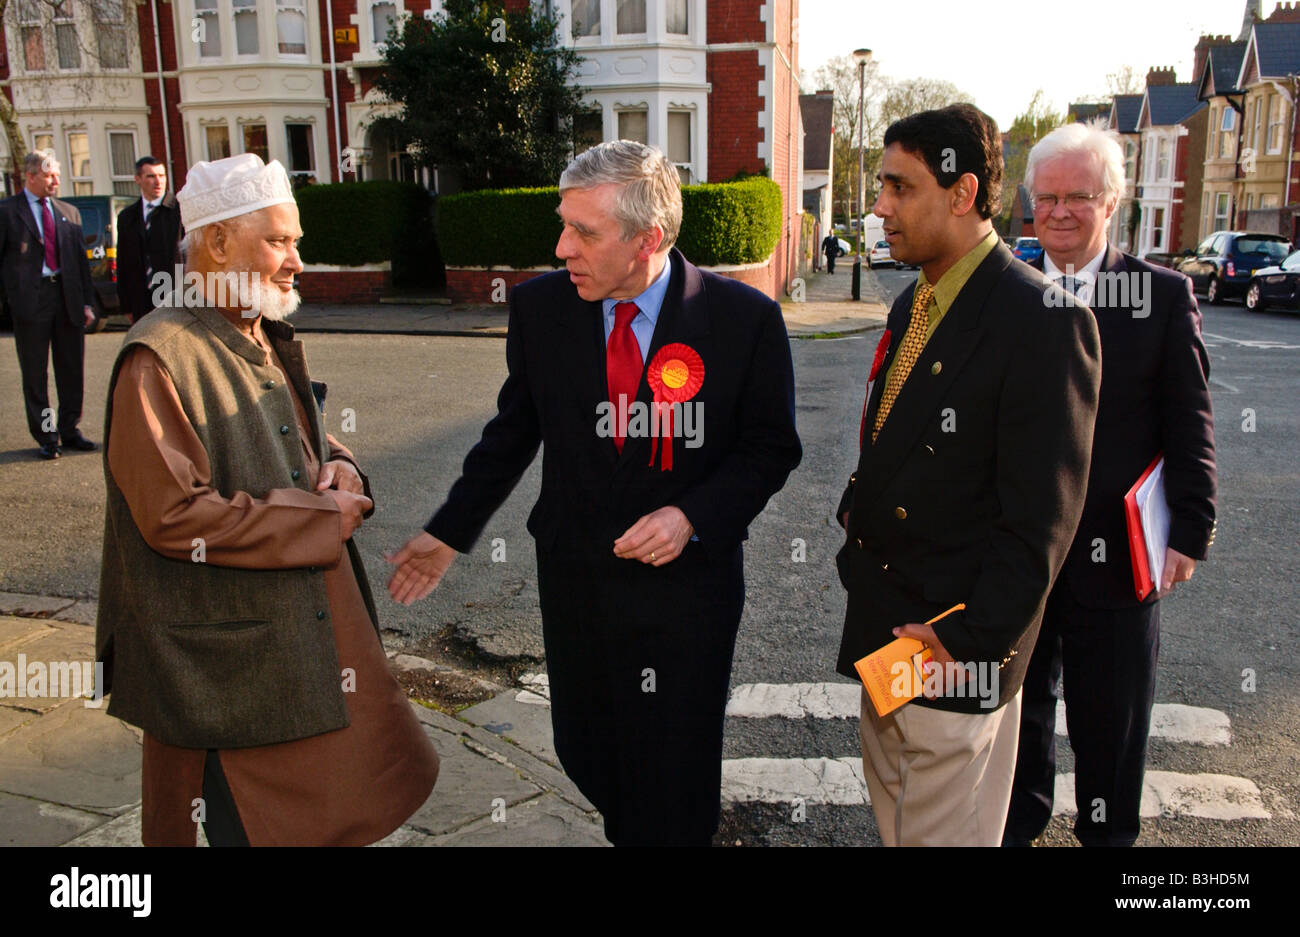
[1002,582,1160,846]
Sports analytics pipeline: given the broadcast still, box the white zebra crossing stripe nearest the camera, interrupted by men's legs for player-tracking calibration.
[722,758,1273,820]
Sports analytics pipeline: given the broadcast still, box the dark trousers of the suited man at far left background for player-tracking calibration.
[13,281,86,444]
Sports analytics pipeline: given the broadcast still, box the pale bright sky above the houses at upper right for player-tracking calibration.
[798,0,1278,130]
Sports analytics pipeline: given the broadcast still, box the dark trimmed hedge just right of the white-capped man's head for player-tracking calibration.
[295,179,442,286]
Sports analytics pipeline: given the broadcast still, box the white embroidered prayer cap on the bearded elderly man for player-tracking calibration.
[176,153,295,231]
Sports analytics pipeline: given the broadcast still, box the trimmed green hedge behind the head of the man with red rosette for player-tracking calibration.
[438,178,781,268]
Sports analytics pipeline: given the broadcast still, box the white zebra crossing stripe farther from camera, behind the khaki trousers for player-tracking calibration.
[727,684,1232,746]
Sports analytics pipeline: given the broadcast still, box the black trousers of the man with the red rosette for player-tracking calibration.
[537,543,745,846]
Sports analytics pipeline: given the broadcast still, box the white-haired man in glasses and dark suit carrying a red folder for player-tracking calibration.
[1004,123,1216,846]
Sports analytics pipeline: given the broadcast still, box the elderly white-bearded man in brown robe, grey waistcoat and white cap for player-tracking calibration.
[96,153,438,845]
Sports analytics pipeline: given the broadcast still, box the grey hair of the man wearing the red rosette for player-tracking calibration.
[560,140,681,251]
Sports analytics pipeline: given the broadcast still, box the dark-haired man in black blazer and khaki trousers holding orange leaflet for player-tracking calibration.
[836,104,1100,846]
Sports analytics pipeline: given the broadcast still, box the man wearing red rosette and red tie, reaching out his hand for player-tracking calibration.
[389,140,801,845]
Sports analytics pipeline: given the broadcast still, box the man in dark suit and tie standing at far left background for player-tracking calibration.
[0,152,95,459]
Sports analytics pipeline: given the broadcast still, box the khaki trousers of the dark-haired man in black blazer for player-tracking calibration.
[858,690,1021,846]
